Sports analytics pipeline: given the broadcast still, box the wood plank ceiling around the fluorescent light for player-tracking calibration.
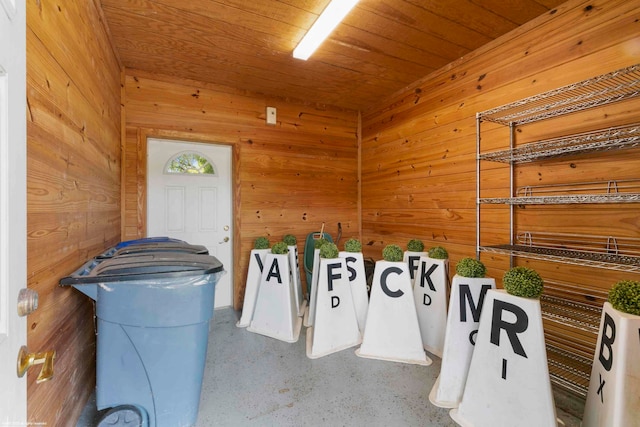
[101,0,564,110]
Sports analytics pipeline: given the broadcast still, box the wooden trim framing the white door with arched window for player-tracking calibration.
[131,128,243,310]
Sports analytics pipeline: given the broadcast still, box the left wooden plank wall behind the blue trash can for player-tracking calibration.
[27,0,121,426]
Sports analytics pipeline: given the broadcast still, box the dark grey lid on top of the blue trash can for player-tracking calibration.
[60,252,223,285]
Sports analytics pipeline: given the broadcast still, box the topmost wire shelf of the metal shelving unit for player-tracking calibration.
[478,64,640,125]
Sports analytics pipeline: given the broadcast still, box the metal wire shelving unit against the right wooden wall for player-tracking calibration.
[476,64,640,397]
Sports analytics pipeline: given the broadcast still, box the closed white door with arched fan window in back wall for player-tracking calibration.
[147,138,233,308]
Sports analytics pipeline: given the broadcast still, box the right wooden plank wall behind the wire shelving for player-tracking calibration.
[361,0,640,387]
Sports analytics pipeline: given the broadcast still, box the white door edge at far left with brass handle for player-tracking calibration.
[0,0,27,425]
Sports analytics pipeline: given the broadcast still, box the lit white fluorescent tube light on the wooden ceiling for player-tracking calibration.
[293,0,359,61]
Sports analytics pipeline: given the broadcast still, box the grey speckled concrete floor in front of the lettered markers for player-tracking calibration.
[77,309,584,427]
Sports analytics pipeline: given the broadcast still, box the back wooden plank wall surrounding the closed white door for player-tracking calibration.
[122,70,359,309]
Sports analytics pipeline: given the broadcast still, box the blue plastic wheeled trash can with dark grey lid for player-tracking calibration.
[60,252,223,427]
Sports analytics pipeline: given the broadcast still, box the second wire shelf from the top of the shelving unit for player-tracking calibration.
[478,123,640,163]
